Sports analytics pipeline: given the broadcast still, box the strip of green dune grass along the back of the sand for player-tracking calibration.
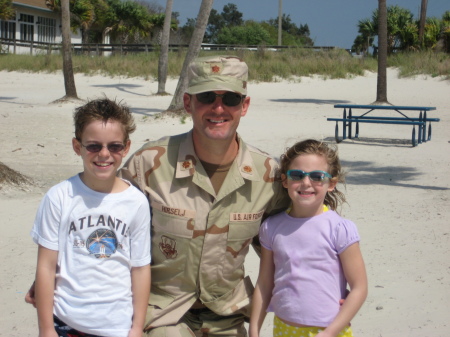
[0,48,450,82]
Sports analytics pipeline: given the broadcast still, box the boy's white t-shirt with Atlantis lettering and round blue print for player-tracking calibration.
[31,175,150,337]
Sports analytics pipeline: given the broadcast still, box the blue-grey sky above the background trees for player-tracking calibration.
[147,0,450,49]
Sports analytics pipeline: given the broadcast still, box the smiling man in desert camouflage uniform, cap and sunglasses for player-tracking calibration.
[26,56,289,337]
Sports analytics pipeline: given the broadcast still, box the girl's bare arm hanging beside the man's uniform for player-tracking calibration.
[249,247,275,337]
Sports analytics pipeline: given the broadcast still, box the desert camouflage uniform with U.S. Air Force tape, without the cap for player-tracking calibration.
[121,131,289,337]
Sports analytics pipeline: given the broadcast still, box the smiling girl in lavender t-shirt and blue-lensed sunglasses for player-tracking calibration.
[250,139,367,337]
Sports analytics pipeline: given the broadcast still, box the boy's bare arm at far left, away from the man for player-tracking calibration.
[35,245,58,337]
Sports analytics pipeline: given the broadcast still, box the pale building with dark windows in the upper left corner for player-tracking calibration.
[0,0,81,54]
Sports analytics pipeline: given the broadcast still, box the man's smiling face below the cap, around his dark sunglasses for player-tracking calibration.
[183,91,250,142]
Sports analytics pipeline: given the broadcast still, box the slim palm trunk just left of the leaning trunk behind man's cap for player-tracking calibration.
[157,0,173,95]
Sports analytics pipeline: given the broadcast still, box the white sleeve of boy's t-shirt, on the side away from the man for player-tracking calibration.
[30,189,61,250]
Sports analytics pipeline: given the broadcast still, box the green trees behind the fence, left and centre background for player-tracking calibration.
[0,0,313,46]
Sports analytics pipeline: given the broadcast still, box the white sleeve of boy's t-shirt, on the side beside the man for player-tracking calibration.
[130,190,151,267]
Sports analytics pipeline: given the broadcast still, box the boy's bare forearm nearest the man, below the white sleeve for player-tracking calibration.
[128,264,151,337]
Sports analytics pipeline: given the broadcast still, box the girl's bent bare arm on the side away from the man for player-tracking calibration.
[316,243,367,337]
